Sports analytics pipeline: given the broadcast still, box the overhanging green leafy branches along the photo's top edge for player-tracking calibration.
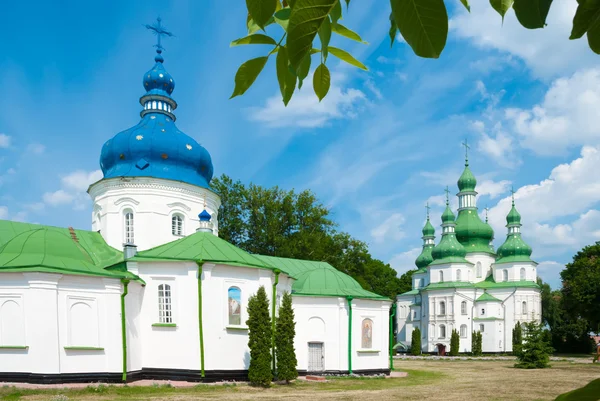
[231,0,600,105]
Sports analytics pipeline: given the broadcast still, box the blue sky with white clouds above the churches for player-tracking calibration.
[0,0,600,288]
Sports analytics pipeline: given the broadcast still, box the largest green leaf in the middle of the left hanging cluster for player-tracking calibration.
[286,0,337,70]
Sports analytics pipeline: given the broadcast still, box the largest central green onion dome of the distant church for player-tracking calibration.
[456,208,494,253]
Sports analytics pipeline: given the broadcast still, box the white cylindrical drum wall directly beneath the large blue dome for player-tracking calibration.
[89,177,221,251]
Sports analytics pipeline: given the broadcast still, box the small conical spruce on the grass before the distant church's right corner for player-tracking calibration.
[515,322,554,369]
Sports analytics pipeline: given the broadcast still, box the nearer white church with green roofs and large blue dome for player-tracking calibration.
[0,28,392,383]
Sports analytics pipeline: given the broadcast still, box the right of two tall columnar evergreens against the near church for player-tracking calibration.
[275,292,298,383]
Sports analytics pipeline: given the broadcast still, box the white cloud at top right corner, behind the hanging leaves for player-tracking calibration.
[451,1,597,77]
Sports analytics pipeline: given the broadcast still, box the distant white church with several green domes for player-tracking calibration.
[396,153,542,354]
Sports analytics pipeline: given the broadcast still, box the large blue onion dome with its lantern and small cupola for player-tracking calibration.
[100,49,213,188]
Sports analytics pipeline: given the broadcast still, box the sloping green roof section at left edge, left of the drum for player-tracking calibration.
[0,220,139,280]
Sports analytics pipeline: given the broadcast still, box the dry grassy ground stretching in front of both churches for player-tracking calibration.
[0,360,600,401]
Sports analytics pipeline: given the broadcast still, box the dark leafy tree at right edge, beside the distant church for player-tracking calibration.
[560,241,600,331]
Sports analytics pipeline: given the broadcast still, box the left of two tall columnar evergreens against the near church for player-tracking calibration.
[246,286,273,387]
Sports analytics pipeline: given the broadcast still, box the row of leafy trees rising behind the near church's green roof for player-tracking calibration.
[211,175,410,299]
